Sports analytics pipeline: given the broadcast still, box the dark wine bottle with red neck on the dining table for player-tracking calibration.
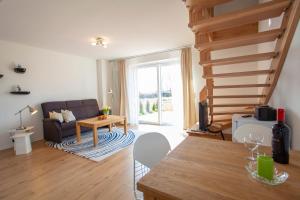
[272,108,290,164]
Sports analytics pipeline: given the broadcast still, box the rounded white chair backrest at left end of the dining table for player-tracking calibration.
[133,132,171,169]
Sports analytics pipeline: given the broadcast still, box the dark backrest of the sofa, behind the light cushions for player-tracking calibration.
[42,99,100,119]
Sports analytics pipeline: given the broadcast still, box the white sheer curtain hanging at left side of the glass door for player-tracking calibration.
[126,65,139,125]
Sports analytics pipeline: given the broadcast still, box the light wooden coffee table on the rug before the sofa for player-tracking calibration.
[76,115,127,146]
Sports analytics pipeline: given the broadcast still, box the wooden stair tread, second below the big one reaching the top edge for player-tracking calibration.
[200,52,276,67]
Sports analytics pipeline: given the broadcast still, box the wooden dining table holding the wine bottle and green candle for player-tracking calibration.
[137,136,300,200]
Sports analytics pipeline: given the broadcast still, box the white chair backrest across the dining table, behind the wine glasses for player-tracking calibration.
[234,124,272,146]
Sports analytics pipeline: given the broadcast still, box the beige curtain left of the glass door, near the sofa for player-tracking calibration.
[117,60,128,118]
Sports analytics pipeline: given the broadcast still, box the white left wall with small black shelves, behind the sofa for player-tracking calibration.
[0,41,97,149]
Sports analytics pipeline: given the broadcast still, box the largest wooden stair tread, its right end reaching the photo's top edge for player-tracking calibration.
[192,0,291,33]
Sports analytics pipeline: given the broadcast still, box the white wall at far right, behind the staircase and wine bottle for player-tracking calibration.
[258,0,300,150]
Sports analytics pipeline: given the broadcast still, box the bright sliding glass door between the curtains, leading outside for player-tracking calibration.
[138,60,183,125]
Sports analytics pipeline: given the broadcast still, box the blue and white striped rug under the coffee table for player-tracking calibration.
[46,128,135,162]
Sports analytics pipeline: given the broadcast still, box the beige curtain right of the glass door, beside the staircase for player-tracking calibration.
[181,48,197,129]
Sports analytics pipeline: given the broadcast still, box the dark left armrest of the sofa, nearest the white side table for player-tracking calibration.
[43,118,62,143]
